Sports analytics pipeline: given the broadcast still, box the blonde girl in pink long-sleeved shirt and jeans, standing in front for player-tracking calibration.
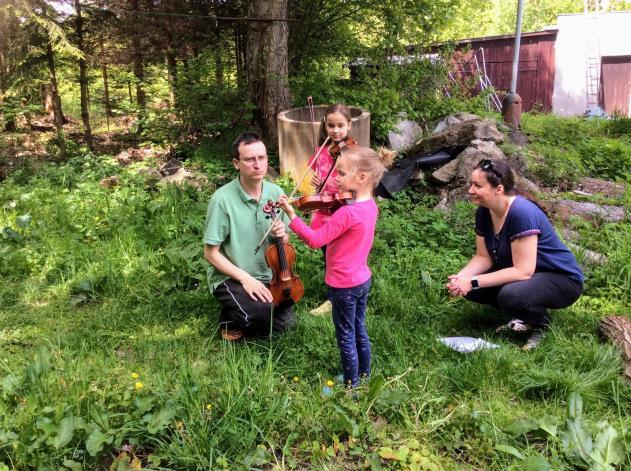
[280,146,385,387]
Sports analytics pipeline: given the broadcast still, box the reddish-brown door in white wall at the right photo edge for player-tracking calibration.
[602,56,631,116]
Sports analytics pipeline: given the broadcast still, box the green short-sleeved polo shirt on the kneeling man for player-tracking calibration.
[204,176,289,293]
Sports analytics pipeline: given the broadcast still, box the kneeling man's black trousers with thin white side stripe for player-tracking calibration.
[213,279,296,336]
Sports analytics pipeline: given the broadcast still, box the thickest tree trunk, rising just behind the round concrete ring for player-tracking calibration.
[246,0,290,148]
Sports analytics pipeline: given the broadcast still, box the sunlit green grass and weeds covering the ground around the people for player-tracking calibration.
[0,116,631,470]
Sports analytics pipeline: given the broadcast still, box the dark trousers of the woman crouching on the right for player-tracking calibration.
[465,272,583,328]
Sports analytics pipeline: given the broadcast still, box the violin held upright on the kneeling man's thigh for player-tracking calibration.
[263,200,305,306]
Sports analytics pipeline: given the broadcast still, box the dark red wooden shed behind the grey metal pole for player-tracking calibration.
[444,29,557,111]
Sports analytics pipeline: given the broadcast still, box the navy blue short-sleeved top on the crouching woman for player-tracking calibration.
[475,196,584,283]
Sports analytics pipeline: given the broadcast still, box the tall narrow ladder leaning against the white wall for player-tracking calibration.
[584,0,609,111]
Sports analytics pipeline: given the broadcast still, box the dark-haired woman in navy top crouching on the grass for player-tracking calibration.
[447,159,584,349]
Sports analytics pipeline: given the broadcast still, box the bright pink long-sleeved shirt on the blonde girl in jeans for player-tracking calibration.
[289,199,379,288]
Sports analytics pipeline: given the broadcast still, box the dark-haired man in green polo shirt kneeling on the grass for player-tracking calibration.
[204,132,295,340]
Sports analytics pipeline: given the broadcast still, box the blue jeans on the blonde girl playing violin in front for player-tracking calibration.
[327,279,371,387]
